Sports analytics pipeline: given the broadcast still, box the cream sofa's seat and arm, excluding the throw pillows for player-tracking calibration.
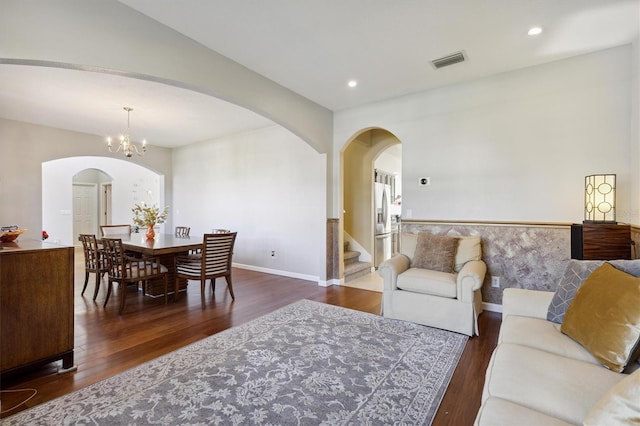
[475,288,640,426]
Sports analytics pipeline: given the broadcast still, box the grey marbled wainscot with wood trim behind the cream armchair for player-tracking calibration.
[402,221,571,305]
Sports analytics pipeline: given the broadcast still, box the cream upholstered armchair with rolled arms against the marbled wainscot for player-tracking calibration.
[378,233,487,336]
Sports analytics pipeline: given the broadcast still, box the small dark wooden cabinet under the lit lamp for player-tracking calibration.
[571,223,631,260]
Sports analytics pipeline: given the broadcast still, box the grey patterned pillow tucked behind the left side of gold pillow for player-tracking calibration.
[547,259,604,324]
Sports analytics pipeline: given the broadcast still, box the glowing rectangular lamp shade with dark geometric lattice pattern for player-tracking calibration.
[584,175,616,223]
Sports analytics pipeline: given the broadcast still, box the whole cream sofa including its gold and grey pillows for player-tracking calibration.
[475,260,640,425]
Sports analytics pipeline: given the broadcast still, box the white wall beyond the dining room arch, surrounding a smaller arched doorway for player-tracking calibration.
[42,157,164,245]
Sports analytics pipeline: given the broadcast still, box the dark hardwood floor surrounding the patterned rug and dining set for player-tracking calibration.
[0,250,500,425]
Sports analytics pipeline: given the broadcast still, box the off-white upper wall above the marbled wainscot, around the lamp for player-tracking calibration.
[333,46,640,223]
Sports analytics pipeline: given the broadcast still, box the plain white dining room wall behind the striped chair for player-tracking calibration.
[171,126,326,284]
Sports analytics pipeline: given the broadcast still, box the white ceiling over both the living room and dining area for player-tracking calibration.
[0,0,640,147]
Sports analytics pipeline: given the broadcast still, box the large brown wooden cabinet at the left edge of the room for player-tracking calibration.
[0,240,74,375]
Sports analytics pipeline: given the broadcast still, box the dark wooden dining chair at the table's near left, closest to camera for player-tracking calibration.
[102,238,169,314]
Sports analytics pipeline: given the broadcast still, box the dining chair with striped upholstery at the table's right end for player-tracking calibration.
[176,232,238,309]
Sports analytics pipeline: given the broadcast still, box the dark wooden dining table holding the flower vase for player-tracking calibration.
[104,233,204,300]
